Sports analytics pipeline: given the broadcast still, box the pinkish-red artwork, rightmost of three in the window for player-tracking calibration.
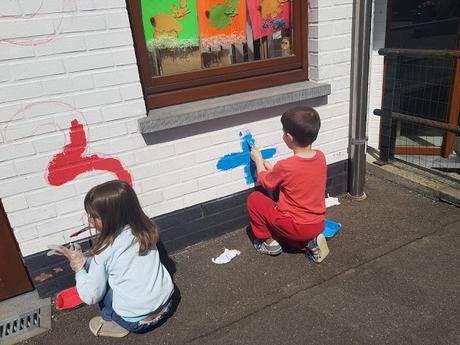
[248,0,291,40]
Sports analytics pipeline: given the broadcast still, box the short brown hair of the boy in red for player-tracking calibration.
[281,107,321,147]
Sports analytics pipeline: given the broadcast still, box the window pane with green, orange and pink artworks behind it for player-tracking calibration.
[141,0,293,76]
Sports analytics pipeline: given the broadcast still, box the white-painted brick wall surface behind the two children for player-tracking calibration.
[0,0,352,255]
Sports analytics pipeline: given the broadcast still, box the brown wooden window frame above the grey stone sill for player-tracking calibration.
[127,0,308,110]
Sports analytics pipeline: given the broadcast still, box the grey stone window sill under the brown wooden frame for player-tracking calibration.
[139,81,331,134]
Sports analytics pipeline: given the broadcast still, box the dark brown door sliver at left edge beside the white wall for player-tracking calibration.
[0,200,33,301]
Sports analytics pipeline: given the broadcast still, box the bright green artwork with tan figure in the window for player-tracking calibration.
[141,0,199,50]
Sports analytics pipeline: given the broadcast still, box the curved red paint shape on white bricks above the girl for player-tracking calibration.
[47,120,132,186]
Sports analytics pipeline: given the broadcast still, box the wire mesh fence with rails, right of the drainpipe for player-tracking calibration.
[374,48,460,181]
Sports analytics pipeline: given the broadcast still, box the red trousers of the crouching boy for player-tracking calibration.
[248,192,324,249]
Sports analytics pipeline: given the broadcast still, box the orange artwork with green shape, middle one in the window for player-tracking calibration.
[197,0,246,49]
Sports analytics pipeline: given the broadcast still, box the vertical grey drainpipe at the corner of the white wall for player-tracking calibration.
[348,0,372,200]
